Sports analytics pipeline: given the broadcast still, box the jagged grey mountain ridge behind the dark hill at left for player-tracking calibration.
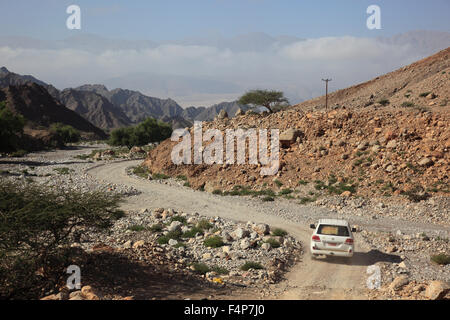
[0,67,250,130]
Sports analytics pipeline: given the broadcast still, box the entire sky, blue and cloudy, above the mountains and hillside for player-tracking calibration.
[0,0,450,106]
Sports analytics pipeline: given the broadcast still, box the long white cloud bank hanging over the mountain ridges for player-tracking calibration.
[0,37,440,104]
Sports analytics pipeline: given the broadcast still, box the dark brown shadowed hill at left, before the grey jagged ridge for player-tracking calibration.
[0,82,106,139]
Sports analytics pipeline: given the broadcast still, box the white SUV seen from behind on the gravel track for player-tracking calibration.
[310,219,356,258]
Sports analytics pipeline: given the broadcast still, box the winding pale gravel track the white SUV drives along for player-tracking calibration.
[87,160,448,299]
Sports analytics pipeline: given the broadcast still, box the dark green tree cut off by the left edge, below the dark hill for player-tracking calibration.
[0,102,25,151]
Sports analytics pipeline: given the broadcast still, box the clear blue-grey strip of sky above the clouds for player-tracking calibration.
[0,0,450,40]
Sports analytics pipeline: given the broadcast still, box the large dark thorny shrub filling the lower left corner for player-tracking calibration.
[0,181,124,299]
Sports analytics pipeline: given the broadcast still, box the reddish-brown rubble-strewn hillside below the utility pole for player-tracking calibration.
[144,48,450,200]
